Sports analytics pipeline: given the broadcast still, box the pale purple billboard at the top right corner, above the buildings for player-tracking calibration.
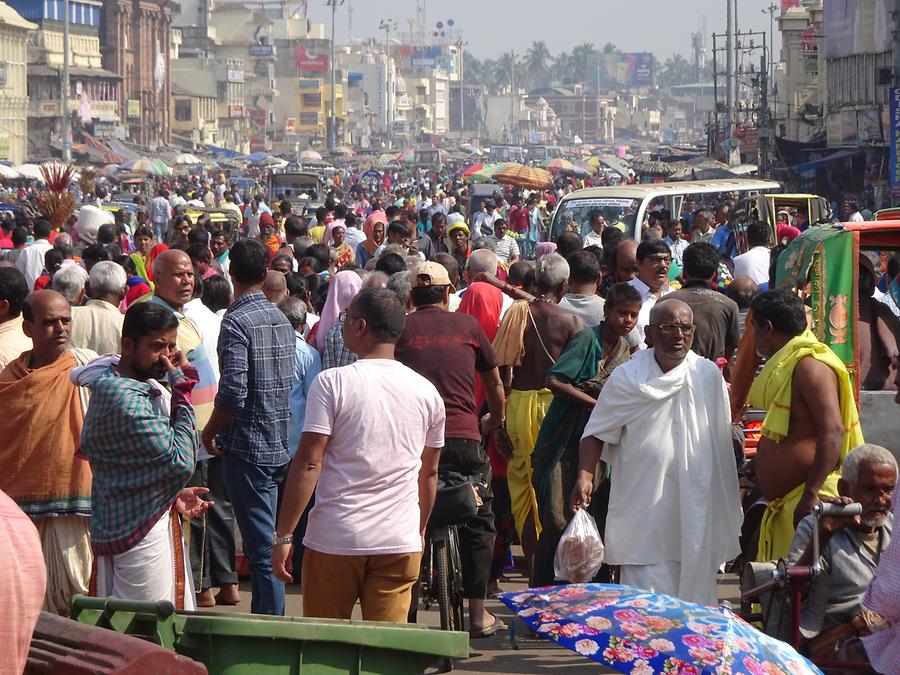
[822,0,894,59]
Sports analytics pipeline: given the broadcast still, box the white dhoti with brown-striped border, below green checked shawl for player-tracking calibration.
[91,511,196,610]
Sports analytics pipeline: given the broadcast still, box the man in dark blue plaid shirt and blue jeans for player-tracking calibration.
[203,239,294,615]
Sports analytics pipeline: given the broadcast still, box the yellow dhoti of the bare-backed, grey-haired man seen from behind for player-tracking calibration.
[506,389,553,540]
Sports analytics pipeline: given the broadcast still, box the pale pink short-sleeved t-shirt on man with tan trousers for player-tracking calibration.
[303,359,444,555]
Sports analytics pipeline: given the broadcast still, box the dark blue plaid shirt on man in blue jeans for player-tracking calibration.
[216,291,296,466]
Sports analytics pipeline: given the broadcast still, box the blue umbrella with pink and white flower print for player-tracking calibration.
[500,584,821,675]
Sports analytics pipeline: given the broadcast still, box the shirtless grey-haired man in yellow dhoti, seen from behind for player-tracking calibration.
[494,253,584,578]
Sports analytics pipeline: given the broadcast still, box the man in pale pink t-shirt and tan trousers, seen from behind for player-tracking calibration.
[272,288,445,623]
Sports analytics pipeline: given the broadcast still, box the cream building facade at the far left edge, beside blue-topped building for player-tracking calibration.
[0,2,37,164]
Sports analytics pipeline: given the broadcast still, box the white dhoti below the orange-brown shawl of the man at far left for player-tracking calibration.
[31,516,93,616]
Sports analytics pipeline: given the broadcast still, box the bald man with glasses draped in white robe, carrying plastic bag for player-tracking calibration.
[570,300,742,605]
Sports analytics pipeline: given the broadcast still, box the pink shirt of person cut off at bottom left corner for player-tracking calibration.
[0,491,47,673]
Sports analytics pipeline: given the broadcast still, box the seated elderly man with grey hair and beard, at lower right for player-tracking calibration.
[788,444,897,660]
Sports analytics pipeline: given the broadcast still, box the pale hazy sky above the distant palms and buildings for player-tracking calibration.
[309,0,780,58]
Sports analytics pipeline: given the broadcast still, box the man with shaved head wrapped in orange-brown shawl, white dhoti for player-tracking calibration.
[0,290,97,615]
